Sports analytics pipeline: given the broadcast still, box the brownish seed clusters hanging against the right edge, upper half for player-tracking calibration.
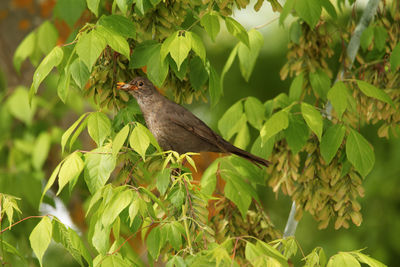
[345,8,400,138]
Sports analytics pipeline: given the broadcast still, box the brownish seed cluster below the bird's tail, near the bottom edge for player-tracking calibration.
[211,198,282,259]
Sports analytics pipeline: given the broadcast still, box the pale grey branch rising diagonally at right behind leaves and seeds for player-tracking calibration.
[283,0,380,238]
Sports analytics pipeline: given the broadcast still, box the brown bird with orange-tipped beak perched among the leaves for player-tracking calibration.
[117,76,270,167]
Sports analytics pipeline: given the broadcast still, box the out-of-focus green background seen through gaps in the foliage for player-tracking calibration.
[0,1,400,266]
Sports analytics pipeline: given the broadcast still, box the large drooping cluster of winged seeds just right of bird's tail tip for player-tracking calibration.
[268,138,364,229]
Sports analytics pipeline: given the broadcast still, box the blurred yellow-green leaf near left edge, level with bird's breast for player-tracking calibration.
[7,86,36,125]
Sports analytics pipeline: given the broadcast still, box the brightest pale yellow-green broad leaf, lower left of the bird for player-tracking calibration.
[57,152,85,195]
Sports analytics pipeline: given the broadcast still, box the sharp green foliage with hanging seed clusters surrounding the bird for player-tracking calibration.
[0,0,400,266]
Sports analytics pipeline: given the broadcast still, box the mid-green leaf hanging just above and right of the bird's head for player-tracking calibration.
[147,43,168,87]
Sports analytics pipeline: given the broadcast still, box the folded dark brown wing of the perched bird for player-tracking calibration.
[165,103,228,152]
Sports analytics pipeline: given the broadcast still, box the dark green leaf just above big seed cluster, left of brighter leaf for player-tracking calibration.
[320,124,346,165]
